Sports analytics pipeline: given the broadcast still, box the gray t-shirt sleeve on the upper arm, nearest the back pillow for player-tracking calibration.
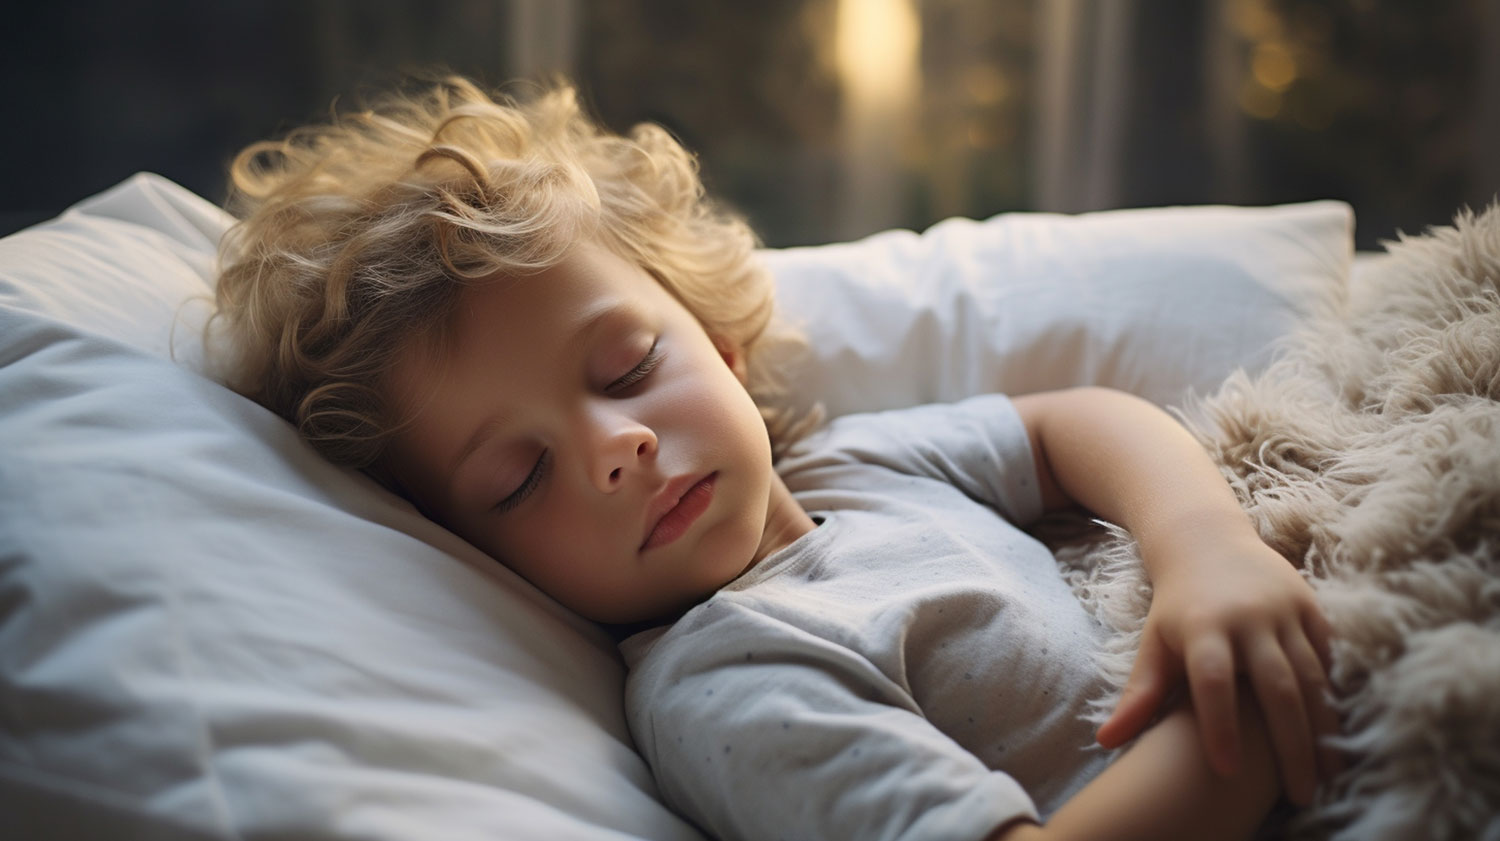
[779,394,1043,526]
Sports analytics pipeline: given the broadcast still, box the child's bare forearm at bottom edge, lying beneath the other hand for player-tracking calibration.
[989,689,1277,841]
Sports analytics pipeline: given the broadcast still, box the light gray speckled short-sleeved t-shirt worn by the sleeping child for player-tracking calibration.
[621,394,1112,841]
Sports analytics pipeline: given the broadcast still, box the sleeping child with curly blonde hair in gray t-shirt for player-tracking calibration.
[208,78,1337,841]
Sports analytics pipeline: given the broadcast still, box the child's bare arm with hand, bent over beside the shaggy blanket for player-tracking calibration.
[1014,388,1334,804]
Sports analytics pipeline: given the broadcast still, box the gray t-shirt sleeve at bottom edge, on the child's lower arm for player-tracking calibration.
[626,603,1037,841]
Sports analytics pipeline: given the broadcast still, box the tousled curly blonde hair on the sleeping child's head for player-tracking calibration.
[216,76,800,468]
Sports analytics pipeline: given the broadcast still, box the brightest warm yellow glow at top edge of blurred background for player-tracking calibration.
[834,0,921,102]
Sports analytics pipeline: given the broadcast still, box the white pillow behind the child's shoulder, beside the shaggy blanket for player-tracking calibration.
[764,201,1353,415]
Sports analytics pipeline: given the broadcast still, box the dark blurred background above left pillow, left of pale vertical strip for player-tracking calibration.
[0,0,522,231]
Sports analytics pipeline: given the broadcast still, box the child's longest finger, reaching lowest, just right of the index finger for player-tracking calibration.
[1245,634,1317,805]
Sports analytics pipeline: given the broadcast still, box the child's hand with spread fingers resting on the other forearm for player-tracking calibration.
[1098,531,1338,805]
